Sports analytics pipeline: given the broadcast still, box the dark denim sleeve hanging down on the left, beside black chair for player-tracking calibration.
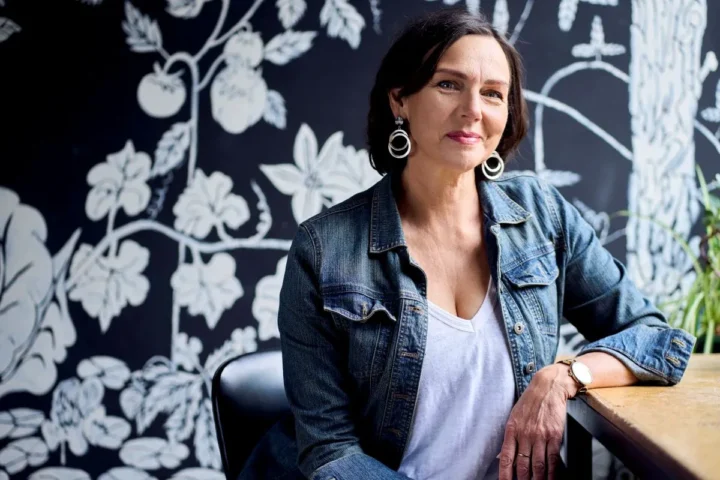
[278,224,408,480]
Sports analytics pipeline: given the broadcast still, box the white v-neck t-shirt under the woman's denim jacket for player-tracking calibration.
[398,280,515,480]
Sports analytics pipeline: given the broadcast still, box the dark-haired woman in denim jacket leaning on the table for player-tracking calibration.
[262,10,694,480]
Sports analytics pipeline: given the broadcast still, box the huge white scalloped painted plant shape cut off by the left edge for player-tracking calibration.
[0,187,77,397]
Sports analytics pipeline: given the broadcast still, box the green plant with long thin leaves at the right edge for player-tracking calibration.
[618,168,720,353]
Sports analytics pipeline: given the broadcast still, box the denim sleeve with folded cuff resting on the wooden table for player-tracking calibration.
[543,184,696,385]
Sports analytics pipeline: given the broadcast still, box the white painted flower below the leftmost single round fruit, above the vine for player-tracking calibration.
[85,140,151,220]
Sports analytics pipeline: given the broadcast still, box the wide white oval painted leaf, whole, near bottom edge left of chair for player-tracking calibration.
[120,437,190,470]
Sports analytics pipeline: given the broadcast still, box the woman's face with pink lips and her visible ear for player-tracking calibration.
[391,35,510,172]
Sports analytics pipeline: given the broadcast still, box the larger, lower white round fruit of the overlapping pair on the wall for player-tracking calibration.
[210,65,268,134]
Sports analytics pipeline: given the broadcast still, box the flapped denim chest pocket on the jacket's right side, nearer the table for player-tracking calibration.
[503,244,560,338]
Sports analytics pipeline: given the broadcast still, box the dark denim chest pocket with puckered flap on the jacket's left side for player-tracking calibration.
[323,292,397,380]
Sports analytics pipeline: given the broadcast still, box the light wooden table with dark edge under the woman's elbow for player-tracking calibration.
[567,354,720,480]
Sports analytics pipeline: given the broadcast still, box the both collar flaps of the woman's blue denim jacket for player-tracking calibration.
[370,172,531,253]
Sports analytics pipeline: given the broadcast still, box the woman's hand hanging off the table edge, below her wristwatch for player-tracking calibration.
[500,364,577,480]
